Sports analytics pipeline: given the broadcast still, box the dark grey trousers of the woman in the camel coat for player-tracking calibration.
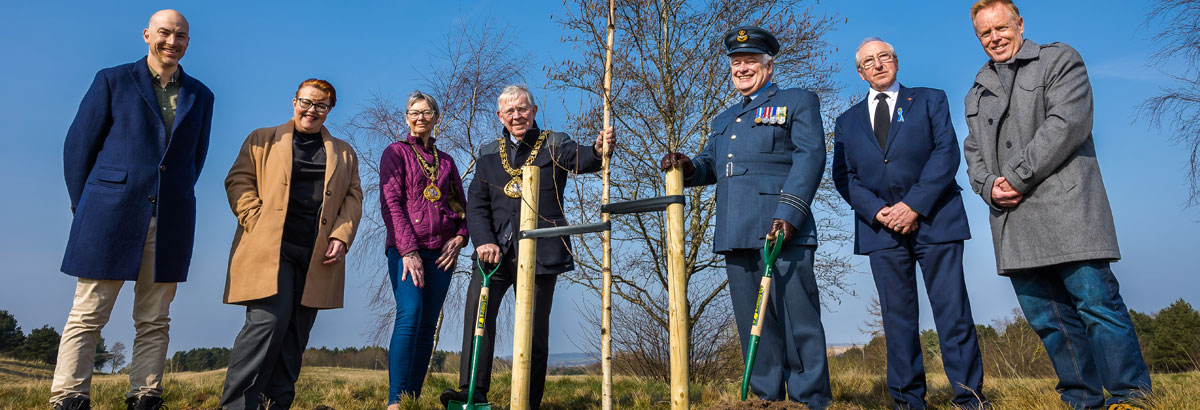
[221,242,317,410]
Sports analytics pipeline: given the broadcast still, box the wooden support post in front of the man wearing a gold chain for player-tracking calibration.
[510,165,541,410]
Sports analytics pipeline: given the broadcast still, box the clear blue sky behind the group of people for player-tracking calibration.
[0,0,1200,359]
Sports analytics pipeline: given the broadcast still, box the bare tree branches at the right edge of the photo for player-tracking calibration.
[1138,0,1200,206]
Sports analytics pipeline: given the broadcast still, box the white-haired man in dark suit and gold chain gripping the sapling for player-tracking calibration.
[440,85,616,409]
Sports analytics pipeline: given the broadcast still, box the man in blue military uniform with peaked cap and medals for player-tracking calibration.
[660,26,830,409]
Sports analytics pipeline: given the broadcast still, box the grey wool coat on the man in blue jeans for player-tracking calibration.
[962,40,1121,275]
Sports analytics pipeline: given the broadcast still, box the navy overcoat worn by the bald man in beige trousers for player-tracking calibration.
[61,58,212,282]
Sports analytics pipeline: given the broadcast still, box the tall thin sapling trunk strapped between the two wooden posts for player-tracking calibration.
[600,0,617,410]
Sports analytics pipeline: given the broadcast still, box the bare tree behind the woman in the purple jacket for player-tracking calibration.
[342,19,530,354]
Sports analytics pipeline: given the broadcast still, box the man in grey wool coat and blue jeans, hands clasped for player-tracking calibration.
[964,0,1151,409]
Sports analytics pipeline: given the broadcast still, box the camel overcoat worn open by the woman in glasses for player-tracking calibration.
[224,120,362,309]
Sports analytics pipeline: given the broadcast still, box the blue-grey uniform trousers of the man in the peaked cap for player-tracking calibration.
[725,246,833,410]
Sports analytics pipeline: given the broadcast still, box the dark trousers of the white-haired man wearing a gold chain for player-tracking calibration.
[458,252,558,410]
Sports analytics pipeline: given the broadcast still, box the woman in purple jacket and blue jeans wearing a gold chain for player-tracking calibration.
[379,91,467,410]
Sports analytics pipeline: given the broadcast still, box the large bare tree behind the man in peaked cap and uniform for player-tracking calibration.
[546,0,852,381]
